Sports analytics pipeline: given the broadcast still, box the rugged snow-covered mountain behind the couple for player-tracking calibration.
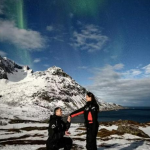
[0,56,122,120]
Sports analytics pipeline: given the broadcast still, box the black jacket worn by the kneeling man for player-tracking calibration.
[48,115,70,142]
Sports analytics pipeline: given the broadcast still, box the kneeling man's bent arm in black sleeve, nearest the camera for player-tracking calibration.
[49,120,65,140]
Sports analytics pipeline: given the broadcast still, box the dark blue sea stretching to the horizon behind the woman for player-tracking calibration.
[72,106,150,123]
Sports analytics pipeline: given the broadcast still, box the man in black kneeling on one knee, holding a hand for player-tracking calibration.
[46,107,72,150]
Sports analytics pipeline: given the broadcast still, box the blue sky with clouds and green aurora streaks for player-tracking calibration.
[0,0,150,106]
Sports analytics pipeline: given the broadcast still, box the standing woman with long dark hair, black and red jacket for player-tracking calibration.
[70,92,99,150]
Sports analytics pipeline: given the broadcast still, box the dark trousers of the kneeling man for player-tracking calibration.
[46,137,72,150]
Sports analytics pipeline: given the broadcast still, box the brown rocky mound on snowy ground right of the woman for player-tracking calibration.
[117,125,149,138]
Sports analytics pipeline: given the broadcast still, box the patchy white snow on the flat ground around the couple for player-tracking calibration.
[0,123,150,150]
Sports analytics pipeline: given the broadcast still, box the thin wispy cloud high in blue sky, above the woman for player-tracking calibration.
[70,24,108,52]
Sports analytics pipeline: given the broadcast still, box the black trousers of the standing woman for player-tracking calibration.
[86,124,98,150]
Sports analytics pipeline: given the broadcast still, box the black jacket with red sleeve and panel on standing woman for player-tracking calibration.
[70,101,99,134]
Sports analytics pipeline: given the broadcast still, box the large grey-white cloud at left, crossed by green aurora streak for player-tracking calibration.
[0,20,46,50]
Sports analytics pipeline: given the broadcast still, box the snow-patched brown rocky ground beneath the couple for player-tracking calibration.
[0,119,150,150]
